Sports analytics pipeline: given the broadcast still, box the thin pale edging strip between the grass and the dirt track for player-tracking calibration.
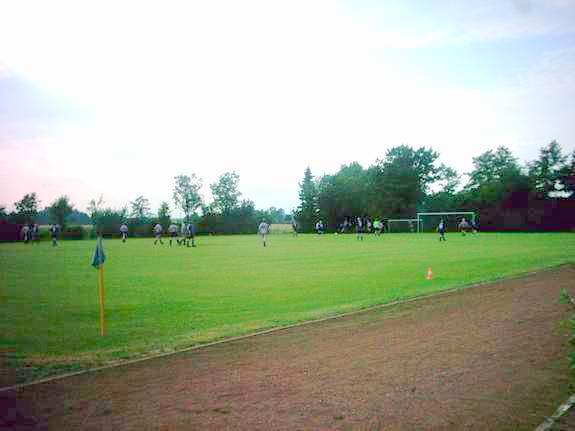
[0,263,573,392]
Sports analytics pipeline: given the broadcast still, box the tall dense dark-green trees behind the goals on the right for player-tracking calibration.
[296,141,575,232]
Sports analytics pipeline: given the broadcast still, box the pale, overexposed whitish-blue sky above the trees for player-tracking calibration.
[0,0,575,216]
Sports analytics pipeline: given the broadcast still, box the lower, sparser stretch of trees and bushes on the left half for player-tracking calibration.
[0,172,291,236]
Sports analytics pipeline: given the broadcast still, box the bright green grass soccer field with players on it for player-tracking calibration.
[0,233,575,381]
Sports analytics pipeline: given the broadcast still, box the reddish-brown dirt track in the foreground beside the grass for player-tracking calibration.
[0,267,575,430]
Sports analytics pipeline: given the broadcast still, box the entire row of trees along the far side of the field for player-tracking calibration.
[0,141,575,235]
